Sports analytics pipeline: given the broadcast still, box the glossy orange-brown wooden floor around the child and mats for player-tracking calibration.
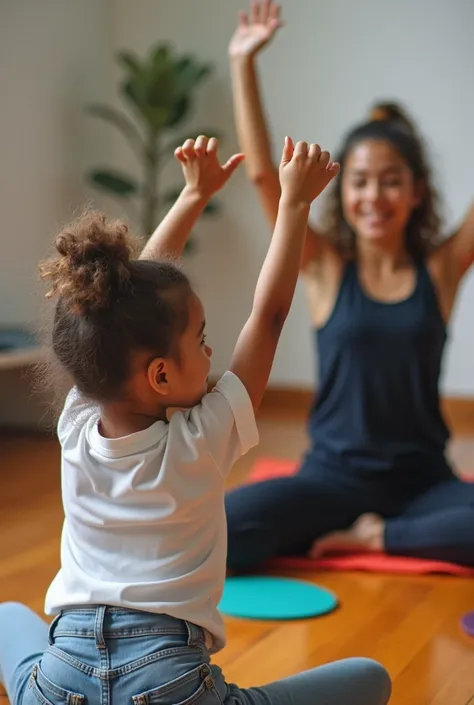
[0,413,474,705]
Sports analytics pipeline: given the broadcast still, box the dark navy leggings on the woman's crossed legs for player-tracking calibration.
[226,462,474,571]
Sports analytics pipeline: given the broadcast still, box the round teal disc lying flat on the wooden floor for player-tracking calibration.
[219,575,338,620]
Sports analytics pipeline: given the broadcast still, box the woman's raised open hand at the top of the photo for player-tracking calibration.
[229,0,283,58]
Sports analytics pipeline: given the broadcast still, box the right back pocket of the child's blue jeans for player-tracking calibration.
[132,664,221,705]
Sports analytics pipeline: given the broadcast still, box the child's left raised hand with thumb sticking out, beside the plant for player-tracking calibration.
[175,135,244,199]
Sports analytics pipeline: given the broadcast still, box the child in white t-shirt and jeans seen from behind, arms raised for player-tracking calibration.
[0,137,390,705]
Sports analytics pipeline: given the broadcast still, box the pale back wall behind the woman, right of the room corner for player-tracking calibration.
[109,0,474,395]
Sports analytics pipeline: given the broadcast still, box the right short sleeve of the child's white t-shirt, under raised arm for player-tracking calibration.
[189,372,259,475]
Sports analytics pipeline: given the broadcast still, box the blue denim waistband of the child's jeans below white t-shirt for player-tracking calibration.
[49,605,206,646]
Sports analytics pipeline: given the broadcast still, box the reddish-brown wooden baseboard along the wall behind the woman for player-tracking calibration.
[260,386,474,435]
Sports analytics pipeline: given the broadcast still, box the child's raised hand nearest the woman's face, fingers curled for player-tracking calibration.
[280,137,339,205]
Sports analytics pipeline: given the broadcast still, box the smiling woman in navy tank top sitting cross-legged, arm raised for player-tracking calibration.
[227,0,474,570]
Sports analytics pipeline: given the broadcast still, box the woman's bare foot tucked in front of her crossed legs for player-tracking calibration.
[309,514,385,558]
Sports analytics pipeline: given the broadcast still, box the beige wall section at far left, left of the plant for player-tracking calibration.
[0,0,112,326]
